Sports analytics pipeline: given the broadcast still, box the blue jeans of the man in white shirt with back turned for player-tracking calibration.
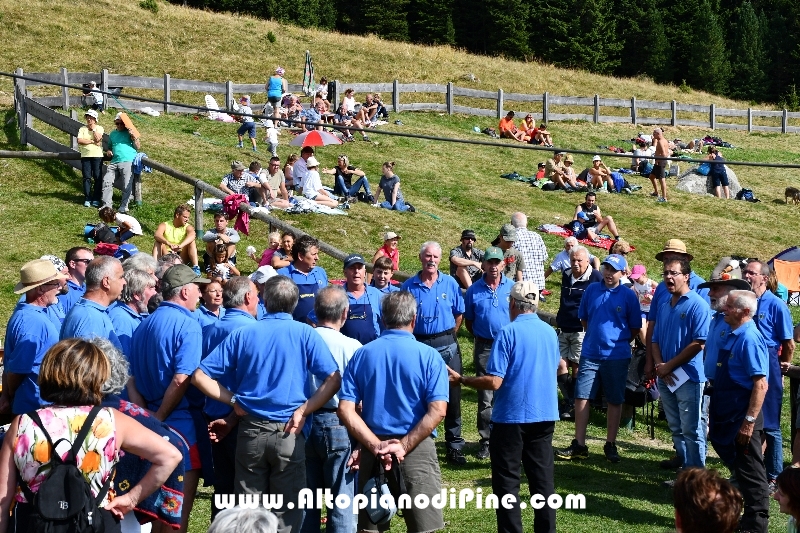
[300,411,358,533]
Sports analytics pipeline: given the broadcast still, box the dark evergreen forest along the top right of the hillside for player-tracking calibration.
[174,0,800,110]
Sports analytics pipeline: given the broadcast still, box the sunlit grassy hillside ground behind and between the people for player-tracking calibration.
[0,0,800,533]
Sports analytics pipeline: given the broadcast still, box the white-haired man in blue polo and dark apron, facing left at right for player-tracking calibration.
[709,288,772,533]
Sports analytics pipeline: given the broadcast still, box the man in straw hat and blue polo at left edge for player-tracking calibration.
[0,259,67,418]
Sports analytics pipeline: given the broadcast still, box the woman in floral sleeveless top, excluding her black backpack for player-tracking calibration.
[0,339,181,533]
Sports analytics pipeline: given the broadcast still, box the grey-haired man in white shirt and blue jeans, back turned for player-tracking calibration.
[303,286,364,532]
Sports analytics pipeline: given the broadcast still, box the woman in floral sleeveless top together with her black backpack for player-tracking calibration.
[0,339,182,533]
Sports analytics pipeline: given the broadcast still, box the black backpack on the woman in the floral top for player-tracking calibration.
[19,406,114,533]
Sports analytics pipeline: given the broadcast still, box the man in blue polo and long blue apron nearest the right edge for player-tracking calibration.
[742,261,794,493]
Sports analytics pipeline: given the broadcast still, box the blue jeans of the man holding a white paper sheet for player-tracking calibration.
[658,379,706,468]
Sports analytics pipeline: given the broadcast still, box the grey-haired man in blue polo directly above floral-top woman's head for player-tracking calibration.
[60,255,125,349]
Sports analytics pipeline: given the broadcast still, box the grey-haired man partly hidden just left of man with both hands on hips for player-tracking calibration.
[198,276,260,521]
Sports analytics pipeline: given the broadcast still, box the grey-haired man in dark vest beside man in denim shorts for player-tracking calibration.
[556,245,603,419]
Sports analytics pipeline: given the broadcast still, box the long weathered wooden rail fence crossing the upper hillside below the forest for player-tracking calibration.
[17,68,800,133]
